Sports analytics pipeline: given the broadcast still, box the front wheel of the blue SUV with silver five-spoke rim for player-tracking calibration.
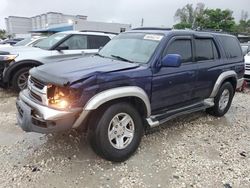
[88,102,144,162]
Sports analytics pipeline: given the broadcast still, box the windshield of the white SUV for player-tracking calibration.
[34,33,68,50]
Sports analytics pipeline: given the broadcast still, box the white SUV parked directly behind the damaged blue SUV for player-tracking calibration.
[0,31,115,91]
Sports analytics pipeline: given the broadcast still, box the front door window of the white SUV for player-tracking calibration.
[60,35,87,50]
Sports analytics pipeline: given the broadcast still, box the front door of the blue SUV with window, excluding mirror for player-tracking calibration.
[151,36,197,113]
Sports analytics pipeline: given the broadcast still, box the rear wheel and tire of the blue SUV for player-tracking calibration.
[206,82,235,117]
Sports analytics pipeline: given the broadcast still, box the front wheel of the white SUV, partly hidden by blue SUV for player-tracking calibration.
[12,67,31,92]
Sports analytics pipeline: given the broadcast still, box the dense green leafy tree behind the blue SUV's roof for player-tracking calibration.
[197,9,236,32]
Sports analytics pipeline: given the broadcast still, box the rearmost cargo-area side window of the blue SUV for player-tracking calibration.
[219,36,242,58]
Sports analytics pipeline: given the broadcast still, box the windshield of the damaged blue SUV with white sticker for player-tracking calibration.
[99,33,163,64]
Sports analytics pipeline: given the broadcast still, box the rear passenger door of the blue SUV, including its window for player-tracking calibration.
[194,37,222,100]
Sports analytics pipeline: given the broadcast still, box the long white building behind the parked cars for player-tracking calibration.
[5,12,131,36]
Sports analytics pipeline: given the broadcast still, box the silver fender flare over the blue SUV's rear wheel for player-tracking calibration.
[209,70,237,98]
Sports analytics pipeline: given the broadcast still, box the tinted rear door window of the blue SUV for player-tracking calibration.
[195,39,219,61]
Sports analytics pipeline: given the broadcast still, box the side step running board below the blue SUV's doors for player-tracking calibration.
[146,98,214,128]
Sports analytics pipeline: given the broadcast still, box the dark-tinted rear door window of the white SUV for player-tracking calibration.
[88,35,110,49]
